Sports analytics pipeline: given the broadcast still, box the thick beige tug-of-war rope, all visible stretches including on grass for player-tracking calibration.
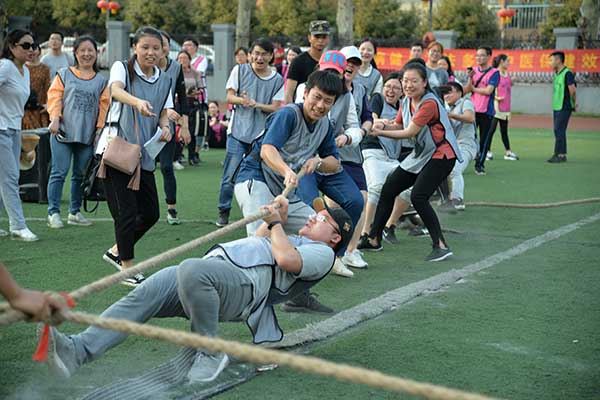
[0,171,600,400]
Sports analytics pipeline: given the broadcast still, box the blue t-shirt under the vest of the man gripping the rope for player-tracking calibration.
[235,103,339,183]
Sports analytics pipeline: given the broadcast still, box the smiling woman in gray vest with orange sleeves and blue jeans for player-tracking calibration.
[48,36,110,228]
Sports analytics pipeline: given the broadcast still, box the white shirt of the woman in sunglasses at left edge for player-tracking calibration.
[0,58,29,130]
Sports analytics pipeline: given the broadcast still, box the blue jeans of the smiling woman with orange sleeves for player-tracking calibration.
[48,135,94,215]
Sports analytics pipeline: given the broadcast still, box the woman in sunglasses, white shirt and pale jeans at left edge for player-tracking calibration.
[0,29,38,242]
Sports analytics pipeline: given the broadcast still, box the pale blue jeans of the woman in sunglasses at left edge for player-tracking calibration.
[0,129,26,231]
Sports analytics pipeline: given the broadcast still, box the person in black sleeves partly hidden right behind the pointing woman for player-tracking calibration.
[158,31,191,225]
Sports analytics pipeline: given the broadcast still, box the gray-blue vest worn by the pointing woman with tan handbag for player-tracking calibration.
[119,62,175,171]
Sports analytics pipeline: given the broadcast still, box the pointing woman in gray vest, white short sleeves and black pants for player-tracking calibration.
[101,27,173,286]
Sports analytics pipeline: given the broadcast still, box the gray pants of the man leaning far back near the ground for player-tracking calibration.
[69,258,253,365]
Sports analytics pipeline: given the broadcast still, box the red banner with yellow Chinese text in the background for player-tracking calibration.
[375,47,600,72]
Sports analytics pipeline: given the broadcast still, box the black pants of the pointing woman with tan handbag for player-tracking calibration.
[104,166,159,261]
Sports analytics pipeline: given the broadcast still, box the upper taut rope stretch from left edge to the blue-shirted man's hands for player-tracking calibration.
[0,169,305,326]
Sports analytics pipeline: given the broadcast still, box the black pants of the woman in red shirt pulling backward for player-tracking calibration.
[369,158,456,247]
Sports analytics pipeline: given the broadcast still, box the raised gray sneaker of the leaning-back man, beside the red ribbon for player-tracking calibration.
[37,324,79,379]
